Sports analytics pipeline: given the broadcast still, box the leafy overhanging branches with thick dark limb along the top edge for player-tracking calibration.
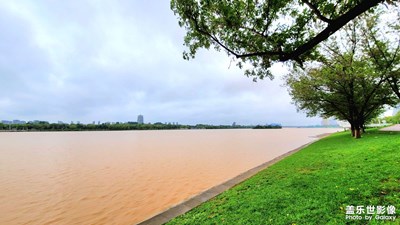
[171,0,398,79]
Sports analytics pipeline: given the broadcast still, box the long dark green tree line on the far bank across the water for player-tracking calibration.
[0,121,281,131]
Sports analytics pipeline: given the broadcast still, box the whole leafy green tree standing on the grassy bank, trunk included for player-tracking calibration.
[286,18,398,138]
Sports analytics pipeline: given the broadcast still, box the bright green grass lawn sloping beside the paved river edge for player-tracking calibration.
[168,130,400,225]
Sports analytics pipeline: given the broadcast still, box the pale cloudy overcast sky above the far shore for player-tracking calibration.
[0,0,328,125]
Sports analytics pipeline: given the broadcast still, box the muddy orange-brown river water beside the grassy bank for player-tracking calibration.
[0,128,336,225]
